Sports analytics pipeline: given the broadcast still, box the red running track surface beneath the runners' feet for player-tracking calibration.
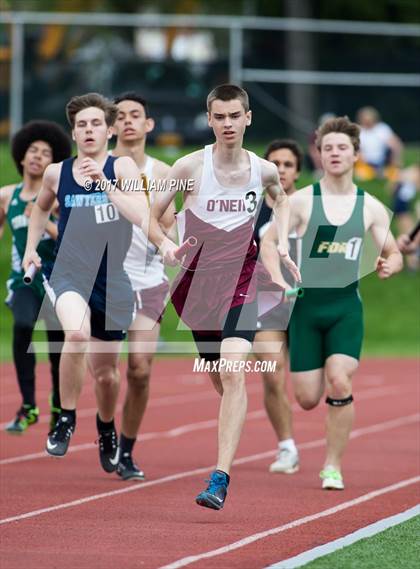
[0,359,419,569]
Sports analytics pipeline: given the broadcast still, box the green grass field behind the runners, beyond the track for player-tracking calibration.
[0,140,420,361]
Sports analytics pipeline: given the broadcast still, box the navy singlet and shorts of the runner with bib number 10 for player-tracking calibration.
[49,151,133,341]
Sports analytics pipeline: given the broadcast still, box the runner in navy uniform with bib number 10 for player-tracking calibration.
[23,93,148,466]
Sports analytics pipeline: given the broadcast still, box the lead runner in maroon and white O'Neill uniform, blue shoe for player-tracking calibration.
[149,85,300,510]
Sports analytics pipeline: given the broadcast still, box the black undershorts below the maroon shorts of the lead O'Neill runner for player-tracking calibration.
[192,301,258,361]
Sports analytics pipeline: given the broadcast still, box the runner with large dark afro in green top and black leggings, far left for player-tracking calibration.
[0,121,71,434]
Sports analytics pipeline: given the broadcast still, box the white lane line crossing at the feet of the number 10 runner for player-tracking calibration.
[0,387,408,466]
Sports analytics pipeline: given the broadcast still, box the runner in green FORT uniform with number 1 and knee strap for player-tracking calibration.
[262,117,402,490]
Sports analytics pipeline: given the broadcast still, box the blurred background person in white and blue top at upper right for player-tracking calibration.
[355,107,403,182]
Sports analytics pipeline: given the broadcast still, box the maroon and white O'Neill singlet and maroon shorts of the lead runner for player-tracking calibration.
[172,145,283,330]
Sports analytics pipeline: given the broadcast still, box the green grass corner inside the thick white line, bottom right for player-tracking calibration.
[303,516,420,569]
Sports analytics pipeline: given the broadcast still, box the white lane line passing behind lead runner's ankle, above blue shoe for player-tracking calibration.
[0,413,420,525]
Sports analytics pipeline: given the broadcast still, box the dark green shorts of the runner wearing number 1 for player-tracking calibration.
[289,289,363,372]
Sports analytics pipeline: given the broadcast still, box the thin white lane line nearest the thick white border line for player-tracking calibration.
[159,476,420,569]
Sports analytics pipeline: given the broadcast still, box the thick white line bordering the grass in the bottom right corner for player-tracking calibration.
[266,506,420,569]
